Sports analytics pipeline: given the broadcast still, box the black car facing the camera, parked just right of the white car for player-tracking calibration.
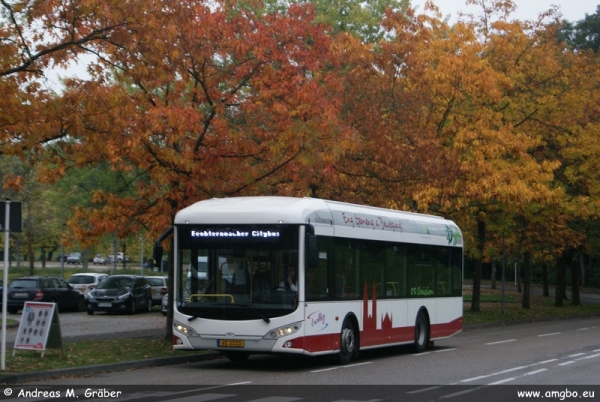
[86,275,152,315]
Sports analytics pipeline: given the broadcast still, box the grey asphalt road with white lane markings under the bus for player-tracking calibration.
[8,318,600,402]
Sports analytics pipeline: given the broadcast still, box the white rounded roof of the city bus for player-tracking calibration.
[175,196,463,246]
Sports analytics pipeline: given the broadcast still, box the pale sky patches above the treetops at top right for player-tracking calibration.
[411,0,600,22]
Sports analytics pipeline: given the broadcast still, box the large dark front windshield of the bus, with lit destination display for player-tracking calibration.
[175,225,299,322]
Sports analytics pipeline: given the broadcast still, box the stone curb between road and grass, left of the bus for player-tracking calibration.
[0,351,221,384]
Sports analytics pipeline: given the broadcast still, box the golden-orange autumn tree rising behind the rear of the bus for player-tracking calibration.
[328,1,590,311]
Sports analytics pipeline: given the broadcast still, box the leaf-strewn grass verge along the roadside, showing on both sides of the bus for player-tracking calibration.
[6,282,600,373]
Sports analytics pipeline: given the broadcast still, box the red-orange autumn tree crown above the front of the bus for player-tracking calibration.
[43,1,337,242]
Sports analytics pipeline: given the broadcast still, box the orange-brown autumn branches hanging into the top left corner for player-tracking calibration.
[0,0,143,155]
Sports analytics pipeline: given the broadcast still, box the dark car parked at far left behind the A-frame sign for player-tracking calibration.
[5,276,85,314]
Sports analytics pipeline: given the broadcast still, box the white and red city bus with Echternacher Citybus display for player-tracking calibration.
[173,197,463,363]
